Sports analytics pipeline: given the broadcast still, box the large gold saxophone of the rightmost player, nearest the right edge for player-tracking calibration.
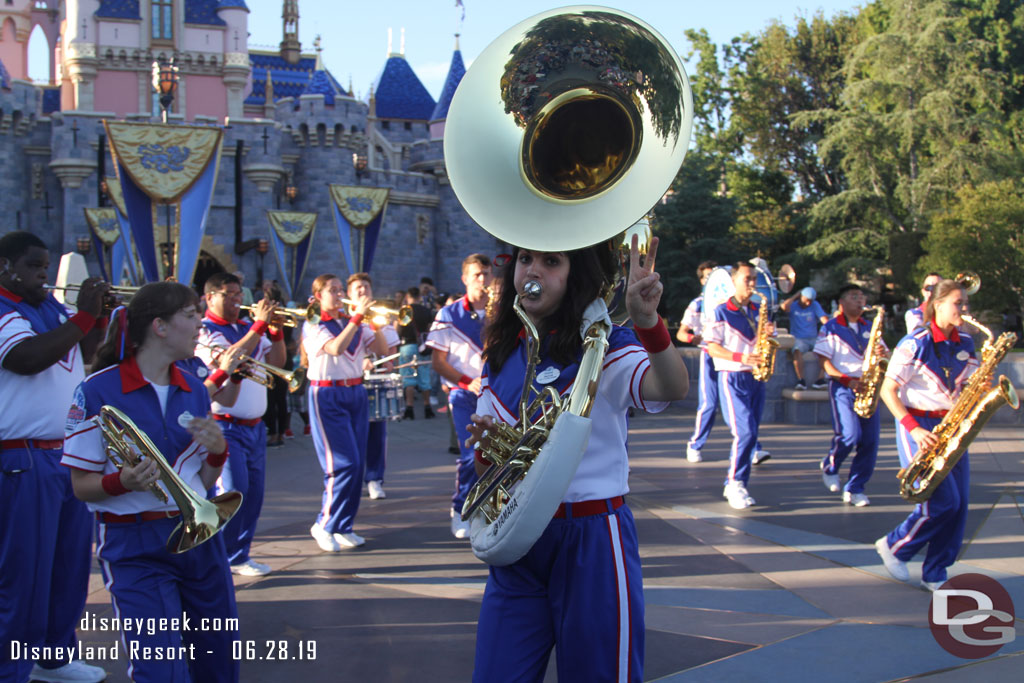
[896,315,1020,503]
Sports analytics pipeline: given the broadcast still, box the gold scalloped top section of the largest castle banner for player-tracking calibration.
[103,120,222,203]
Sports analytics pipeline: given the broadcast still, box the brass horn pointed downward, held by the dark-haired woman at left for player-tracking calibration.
[94,405,242,553]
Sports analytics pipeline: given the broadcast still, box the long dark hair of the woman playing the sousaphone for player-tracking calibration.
[483,242,618,373]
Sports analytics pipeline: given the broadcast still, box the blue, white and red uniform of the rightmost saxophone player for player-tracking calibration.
[878,322,979,584]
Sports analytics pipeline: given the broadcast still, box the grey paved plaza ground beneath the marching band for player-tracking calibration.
[72,407,1024,683]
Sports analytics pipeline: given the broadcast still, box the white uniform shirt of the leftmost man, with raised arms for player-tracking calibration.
[0,296,85,439]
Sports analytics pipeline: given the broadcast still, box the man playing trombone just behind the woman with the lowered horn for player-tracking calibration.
[196,272,285,577]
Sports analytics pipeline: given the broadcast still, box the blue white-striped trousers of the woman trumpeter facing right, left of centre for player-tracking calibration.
[309,384,369,533]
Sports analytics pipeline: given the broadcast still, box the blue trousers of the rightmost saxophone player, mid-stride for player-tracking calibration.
[886,418,971,583]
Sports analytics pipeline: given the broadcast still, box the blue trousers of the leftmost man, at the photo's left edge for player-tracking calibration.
[0,447,92,681]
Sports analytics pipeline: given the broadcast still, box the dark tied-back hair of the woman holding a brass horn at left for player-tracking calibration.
[92,282,199,372]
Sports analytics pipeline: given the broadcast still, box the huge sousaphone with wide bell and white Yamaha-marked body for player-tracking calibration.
[444,6,693,565]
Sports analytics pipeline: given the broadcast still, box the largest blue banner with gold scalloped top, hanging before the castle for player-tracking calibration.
[103,121,223,285]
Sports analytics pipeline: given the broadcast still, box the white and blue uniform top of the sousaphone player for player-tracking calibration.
[476,328,668,503]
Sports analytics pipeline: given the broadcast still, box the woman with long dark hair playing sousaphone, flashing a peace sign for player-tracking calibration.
[471,240,688,682]
